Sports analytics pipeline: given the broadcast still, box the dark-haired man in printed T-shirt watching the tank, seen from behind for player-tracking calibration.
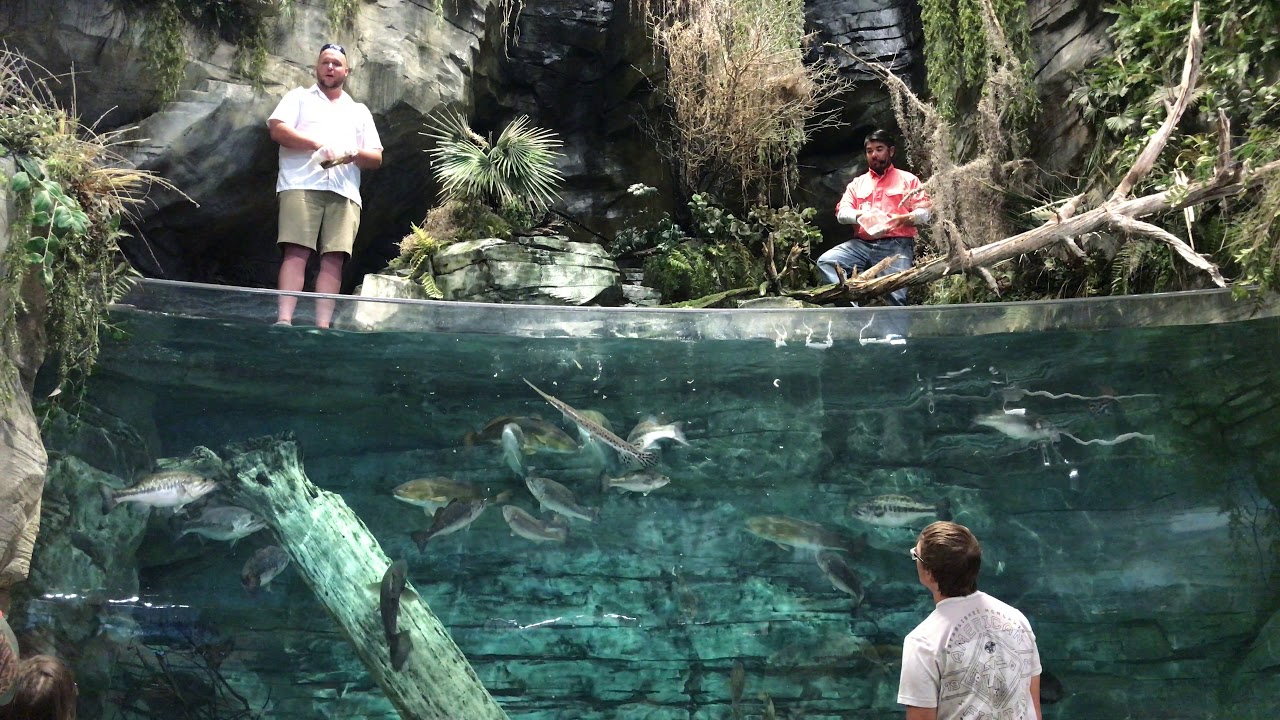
[897,521,1041,720]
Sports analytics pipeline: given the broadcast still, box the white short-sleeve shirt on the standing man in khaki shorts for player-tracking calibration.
[268,85,383,205]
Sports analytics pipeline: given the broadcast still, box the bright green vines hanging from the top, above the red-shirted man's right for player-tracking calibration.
[920,0,1036,120]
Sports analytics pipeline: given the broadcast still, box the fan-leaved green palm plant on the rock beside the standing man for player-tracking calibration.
[422,111,562,210]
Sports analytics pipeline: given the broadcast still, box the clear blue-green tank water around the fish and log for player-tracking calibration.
[17,286,1280,720]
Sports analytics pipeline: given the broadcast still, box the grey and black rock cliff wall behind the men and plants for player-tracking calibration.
[0,0,1102,287]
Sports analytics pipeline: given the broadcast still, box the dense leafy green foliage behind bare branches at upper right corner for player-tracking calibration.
[1073,0,1280,288]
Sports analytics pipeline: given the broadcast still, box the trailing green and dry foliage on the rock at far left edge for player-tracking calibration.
[0,50,160,396]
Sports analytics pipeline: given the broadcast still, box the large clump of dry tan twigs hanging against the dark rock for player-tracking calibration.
[636,0,842,202]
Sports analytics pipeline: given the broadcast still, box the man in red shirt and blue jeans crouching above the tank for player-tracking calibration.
[818,129,933,305]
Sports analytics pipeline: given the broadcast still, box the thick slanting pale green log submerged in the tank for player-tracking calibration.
[207,437,507,720]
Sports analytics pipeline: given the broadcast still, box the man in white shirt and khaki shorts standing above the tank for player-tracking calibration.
[266,42,383,328]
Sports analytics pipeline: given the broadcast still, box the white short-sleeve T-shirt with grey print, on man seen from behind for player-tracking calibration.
[897,592,1041,720]
